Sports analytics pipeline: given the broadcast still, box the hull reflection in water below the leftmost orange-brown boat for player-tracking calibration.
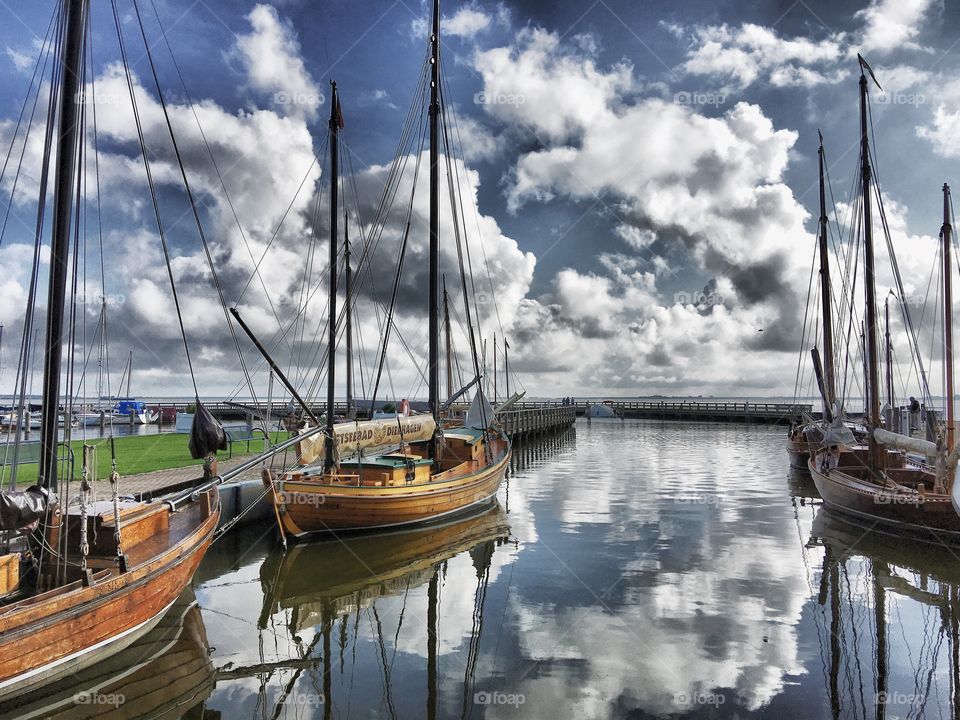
[0,590,214,720]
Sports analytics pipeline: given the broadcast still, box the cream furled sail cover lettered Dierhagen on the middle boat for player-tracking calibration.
[300,415,437,465]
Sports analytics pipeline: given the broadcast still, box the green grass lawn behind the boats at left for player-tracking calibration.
[0,432,289,485]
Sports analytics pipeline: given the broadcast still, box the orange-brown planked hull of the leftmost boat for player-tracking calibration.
[0,488,220,697]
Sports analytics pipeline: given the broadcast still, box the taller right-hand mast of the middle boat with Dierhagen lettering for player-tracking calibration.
[428,0,440,458]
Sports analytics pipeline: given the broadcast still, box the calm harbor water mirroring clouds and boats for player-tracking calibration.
[7,420,960,720]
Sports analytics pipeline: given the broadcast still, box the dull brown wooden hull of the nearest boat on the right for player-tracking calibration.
[808,459,960,543]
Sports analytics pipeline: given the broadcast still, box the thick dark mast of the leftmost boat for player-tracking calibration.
[40,0,87,491]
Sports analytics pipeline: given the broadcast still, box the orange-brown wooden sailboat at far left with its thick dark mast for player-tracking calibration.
[0,0,220,697]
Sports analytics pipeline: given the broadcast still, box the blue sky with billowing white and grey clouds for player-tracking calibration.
[0,0,960,397]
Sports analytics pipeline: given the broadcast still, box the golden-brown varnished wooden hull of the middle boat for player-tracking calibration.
[274,434,510,537]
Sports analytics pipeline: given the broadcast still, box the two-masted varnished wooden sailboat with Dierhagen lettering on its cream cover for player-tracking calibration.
[254,0,510,537]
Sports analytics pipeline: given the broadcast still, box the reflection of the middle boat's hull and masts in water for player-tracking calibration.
[249,502,509,717]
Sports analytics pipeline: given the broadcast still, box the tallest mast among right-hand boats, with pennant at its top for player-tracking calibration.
[858,56,880,467]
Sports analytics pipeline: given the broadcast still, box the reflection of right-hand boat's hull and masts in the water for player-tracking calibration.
[808,507,960,719]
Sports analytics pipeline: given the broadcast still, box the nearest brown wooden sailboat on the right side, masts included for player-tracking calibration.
[809,58,960,542]
